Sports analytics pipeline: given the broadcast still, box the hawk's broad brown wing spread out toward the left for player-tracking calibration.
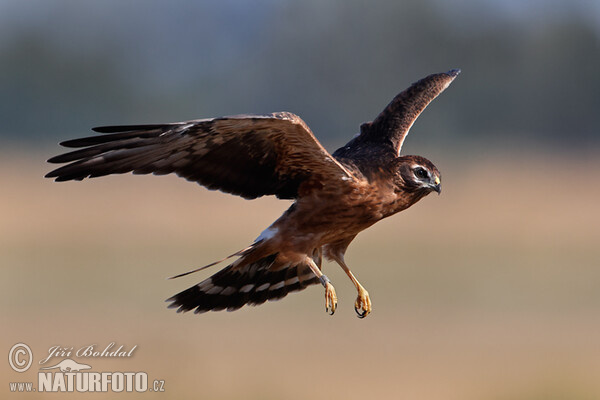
[46,112,354,199]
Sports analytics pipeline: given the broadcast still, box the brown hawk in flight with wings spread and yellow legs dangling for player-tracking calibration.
[46,69,460,318]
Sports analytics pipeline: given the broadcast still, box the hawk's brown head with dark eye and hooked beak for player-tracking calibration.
[395,156,442,197]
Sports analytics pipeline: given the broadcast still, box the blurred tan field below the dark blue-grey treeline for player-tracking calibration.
[0,153,600,400]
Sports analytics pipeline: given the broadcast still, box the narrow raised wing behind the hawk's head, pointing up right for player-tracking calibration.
[333,69,460,158]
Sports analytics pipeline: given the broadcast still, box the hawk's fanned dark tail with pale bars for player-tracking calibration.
[166,250,321,313]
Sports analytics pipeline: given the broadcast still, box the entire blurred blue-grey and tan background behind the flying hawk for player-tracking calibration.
[0,0,600,400]
